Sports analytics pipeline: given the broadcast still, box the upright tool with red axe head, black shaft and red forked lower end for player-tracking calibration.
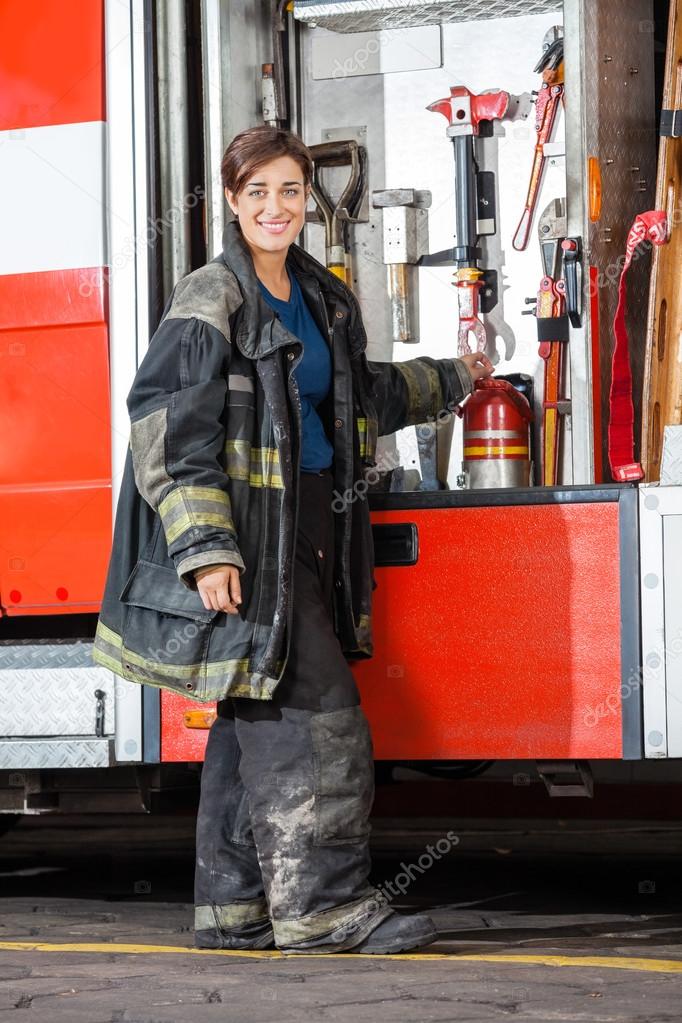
[420,86,518,355]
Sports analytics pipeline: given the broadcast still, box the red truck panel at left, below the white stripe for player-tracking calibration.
[0,268,111,615]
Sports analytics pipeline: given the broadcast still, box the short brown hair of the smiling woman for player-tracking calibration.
[220,125,313,196]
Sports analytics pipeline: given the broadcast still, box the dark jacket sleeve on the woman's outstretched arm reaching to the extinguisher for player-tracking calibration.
[367,356,473,437]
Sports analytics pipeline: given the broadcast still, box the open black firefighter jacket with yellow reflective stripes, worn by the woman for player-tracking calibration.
[93,213,472,701]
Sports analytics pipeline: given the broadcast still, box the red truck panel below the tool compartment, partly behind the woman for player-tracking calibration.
[162,491,623,760]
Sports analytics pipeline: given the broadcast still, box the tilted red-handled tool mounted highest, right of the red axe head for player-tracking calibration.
[512,37,563,252]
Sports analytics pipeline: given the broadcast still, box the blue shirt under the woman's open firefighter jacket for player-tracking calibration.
[259,267,333,473]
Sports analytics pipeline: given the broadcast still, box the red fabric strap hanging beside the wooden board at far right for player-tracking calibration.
[608,210,668,483]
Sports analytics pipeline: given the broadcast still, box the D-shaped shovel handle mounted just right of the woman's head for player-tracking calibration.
[306,139,367,287]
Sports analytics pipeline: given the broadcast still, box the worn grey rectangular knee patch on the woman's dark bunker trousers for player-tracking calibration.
[310,706,374,845]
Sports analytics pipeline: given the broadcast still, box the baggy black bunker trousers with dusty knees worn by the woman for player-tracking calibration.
[194,471,391,950]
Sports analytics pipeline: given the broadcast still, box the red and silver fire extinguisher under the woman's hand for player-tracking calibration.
[462,376,533,490]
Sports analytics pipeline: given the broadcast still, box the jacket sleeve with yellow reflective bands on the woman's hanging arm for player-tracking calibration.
[127,317,244,589]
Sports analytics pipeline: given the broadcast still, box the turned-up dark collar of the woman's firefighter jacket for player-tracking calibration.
[218,220,367,359]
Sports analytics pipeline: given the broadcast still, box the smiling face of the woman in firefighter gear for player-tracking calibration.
[225,157,310,259]
